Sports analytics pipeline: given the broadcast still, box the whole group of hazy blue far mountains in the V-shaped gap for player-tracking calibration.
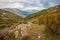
[4,8,38,17]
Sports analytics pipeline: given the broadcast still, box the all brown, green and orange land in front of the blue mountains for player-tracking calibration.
[0,5,60,40]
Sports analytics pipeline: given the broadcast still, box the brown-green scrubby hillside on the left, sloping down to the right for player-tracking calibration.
[0,9,23,28]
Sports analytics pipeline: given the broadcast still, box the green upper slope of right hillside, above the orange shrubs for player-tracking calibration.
[26,5,60,19]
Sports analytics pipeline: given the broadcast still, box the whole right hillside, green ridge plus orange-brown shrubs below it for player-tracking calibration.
[28,5,60,35]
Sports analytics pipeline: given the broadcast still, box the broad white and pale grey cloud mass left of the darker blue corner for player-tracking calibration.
[0,0,44,10]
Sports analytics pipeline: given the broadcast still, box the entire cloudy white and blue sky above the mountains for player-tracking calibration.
[0,0,60,10]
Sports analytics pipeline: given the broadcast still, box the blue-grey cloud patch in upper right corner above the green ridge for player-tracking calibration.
[40,0,60,8]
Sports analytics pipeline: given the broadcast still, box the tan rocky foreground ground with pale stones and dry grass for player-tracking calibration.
[0,23,59,40]
